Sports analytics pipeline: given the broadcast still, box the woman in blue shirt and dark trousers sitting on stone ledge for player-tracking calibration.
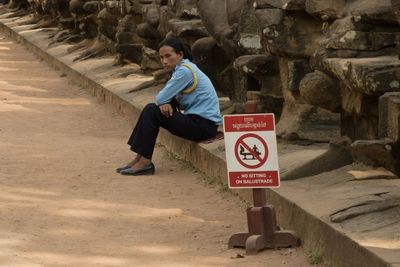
[117,37,222,175]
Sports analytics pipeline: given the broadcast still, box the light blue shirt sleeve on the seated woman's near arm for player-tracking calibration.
[156,67,193,105]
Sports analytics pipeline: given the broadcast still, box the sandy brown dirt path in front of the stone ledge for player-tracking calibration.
[0,35,322,267]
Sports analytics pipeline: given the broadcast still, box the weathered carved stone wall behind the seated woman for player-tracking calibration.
[2,0,400,174]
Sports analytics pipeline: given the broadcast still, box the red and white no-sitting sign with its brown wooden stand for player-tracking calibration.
[224,114,300,254]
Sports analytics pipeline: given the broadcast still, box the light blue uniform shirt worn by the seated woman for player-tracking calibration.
[156,59,222,125]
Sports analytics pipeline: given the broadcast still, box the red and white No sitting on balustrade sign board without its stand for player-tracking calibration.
[224,113,280,188]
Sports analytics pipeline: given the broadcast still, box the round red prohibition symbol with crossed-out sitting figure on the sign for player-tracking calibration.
[234,133,268,169]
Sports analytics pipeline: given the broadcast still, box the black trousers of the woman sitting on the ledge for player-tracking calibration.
[128,103,218,159]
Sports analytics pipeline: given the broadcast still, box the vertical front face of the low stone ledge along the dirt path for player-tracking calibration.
[0,21,393,267]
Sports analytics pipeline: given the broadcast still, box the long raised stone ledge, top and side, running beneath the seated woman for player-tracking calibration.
[0,6,400,267]
